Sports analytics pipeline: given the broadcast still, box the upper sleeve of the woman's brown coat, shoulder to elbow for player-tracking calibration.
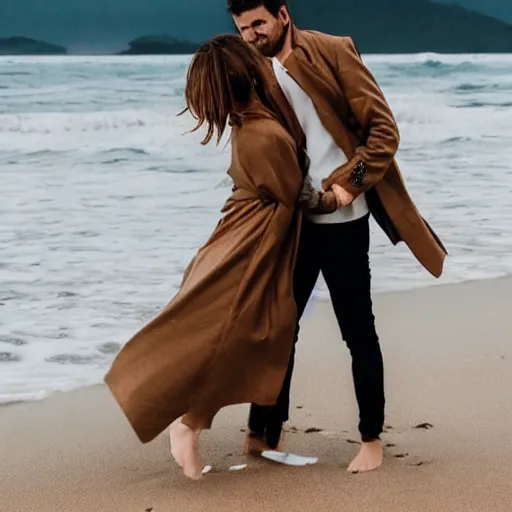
[238,129,302,208]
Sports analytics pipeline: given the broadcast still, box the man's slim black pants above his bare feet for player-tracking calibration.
[249,215,385,448]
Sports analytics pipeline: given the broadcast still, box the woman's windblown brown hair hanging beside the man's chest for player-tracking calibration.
[180,34,282,145]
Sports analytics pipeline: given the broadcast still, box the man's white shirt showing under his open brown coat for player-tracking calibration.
[272,58,368,224]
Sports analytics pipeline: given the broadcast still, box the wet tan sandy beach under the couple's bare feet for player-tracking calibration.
[0,278,512,512]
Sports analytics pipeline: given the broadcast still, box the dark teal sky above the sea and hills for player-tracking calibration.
[0,0,512,53]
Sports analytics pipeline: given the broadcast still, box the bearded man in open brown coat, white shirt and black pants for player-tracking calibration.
[228,0,446,472]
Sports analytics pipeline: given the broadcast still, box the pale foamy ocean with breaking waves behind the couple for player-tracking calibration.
[0,54,512,403]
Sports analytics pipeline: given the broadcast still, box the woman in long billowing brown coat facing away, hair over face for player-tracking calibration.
[105,35,333,479]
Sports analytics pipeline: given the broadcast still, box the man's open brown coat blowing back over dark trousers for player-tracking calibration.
[285,28,447,277]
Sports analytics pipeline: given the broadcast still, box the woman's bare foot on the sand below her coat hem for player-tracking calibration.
[169,418,204,480]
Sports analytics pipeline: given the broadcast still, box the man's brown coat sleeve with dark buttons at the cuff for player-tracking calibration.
[323,37,400,197]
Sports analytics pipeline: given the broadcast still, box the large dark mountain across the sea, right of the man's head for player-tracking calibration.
[292,0,512,53]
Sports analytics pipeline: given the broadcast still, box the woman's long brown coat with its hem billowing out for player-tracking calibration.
[105,112,302,442]
